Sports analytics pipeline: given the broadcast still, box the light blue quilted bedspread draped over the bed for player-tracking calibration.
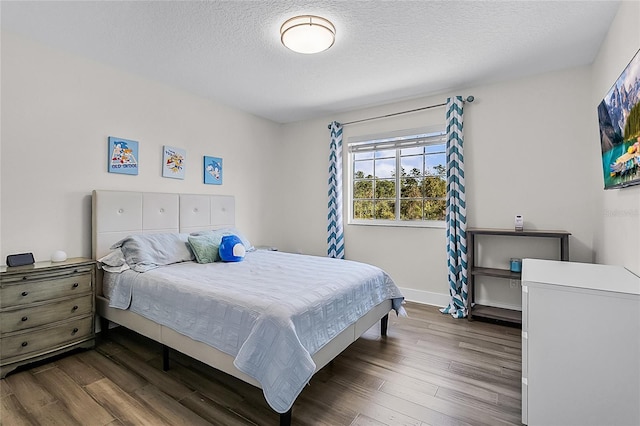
[103,250,403,413]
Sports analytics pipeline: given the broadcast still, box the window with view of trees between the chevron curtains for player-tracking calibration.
[349,132,447,225]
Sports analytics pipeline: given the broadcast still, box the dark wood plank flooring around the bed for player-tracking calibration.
[0,303,521,426]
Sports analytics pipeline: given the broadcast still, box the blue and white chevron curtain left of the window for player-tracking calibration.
[327,121,344,259]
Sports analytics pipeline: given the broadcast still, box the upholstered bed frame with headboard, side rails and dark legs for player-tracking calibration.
[92,190,391,425]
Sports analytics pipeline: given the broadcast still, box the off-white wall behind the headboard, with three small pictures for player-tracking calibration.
[0,32,281,262]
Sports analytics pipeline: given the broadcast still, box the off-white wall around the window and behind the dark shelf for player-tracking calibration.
[279,67,600,307]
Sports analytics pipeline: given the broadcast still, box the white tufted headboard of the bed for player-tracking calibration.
[91,190,235,259]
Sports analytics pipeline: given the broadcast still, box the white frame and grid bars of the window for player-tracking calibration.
[346,126,447,228]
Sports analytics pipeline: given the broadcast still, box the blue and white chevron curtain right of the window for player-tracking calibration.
[440,96,468,318]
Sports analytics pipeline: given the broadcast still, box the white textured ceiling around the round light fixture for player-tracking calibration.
[0,0,619,123]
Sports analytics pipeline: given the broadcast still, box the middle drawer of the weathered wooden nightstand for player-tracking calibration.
[0,294,93,333]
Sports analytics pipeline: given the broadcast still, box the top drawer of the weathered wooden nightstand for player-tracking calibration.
[0,271,92,308]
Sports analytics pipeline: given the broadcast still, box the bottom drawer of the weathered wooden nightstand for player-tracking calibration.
[0,315,93,364]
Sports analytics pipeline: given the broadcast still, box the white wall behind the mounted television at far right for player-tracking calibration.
[589,1,640,275]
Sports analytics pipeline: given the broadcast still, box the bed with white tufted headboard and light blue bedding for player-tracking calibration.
[92,190,403,425]
